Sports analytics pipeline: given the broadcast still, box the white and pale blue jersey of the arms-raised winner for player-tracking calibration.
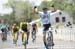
[39,12,50,24]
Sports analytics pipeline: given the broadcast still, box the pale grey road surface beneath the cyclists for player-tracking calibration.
[0,29,75,49]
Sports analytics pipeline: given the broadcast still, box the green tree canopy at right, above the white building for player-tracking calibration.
[41,0,75,23]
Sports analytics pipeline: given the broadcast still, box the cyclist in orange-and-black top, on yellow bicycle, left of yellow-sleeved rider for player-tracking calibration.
[12,23,19,45]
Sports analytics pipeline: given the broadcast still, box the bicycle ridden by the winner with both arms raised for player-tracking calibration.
[46,28,54,49]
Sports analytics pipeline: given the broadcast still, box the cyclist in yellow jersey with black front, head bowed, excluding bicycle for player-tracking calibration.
[20,22,30,44]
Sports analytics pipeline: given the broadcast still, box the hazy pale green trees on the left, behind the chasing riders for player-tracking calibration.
[5,0,36,21]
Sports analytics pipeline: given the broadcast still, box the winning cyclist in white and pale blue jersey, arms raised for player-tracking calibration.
[34,6,51,48]
